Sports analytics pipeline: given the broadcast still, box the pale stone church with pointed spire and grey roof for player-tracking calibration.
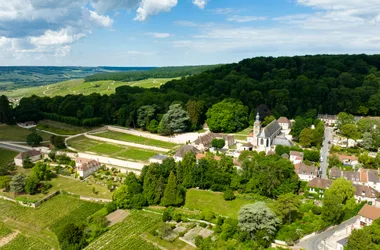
[247,113,293,153]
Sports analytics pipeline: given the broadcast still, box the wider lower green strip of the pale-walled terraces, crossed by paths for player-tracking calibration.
[67,136,158,161]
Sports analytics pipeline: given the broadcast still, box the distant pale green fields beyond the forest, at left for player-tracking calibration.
[0,78,175,98]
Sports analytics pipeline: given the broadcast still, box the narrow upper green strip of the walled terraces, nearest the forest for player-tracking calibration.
[94,131,178,149]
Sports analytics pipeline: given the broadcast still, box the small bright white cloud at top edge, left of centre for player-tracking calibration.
[135,0,178,21]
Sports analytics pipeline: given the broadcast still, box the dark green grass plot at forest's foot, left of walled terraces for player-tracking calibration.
[37,120,88,135]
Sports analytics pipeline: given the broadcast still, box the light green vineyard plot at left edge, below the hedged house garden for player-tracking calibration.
[0,194,98,229]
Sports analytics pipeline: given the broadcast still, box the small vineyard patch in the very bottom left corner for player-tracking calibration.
[0,234,51,250]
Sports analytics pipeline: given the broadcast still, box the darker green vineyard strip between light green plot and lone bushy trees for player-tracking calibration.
[49,202,103,235]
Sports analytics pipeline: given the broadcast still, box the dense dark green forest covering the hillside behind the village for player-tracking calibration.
[2,54,380,132]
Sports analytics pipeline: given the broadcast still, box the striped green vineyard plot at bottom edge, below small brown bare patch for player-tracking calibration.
[86,211,161,250]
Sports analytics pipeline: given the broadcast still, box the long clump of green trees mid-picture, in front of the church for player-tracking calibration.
[113,151,300,209]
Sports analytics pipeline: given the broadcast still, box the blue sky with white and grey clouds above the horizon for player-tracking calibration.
[0,0,380,66]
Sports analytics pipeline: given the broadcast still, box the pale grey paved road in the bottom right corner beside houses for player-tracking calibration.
[297,216,357,250]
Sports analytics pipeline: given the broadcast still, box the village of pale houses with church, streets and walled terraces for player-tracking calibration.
[0,114,380,250]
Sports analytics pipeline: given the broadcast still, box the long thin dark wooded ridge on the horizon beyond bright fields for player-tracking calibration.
[85,65,218,82]
